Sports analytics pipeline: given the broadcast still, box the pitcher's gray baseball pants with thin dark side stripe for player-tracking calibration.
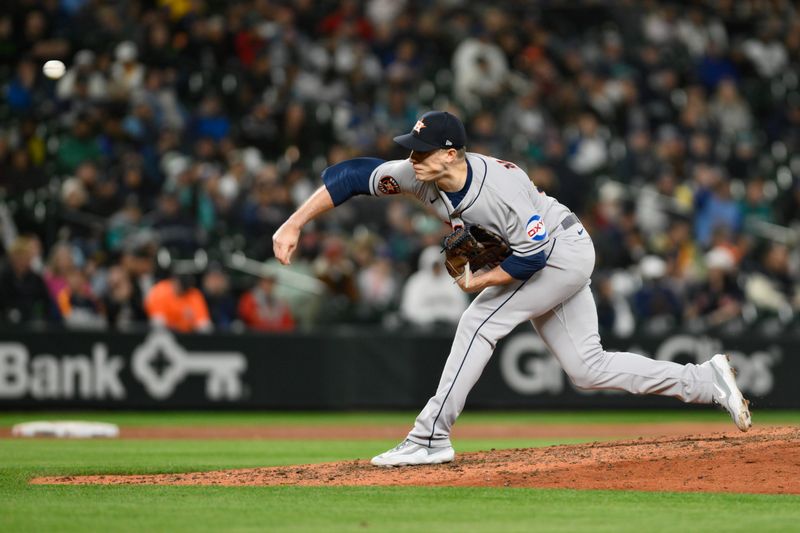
[408,224,714,447]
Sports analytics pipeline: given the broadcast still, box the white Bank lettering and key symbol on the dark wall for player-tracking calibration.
[0,331,247,401]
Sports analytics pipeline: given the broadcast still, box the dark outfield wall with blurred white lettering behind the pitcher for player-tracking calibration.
[0,327,800,409]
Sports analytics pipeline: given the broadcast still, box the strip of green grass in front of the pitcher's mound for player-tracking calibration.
[6,487,800,533]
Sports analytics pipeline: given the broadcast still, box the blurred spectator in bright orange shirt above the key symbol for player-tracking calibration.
[144,274,212,333]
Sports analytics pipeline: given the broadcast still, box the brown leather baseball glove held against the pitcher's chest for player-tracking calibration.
[442,224,511,278]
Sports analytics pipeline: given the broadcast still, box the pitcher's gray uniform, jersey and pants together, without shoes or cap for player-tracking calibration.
[370,153,714,447]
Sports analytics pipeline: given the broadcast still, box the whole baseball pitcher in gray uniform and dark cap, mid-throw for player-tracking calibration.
[272,111,751,466]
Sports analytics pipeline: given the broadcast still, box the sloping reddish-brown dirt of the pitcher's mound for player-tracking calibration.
[31,427,800,494]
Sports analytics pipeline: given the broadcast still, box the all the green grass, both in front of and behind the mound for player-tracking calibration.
[0,411,800,533]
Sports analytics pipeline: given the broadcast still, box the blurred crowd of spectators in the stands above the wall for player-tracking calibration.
[0,0,800,336]
